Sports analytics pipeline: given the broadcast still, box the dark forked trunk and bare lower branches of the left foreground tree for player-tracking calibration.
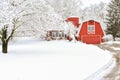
[0,18,18,53]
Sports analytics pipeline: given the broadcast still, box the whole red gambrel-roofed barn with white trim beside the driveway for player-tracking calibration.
[78,20,104,44]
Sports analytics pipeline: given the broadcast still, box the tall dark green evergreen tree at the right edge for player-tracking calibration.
[106,0,120,40]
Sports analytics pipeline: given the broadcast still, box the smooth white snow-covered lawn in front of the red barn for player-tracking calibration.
[0,40,112,80]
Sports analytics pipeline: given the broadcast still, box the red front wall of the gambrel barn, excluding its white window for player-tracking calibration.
[78,21,104,43]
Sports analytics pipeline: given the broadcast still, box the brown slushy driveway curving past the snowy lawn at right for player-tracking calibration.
[97,43,120,80]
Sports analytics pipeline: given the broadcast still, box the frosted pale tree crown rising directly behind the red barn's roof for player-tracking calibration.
[80,2,106,30]
